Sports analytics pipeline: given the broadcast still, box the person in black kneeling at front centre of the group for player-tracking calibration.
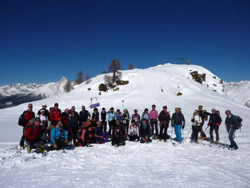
[111,120,125,146]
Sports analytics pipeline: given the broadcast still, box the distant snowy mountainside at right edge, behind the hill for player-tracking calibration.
[224,81,250,107]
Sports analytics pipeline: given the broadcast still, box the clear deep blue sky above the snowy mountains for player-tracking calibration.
[0,0,250,85]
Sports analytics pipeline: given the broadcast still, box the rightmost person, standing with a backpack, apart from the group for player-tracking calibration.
[225,110,240,150]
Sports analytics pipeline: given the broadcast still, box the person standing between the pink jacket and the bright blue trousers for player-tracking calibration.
[159,106,170,141]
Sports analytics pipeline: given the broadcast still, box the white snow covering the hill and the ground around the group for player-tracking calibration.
[0,64,250,188]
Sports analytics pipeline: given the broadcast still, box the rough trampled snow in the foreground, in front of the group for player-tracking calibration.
[0,141,250,188]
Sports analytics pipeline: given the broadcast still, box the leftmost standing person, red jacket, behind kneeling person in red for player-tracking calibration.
[20,103,35,149]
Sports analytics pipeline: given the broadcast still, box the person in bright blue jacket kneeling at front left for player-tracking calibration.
[50,121,68,150]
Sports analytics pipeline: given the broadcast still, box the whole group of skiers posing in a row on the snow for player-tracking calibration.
[19,103,239,153]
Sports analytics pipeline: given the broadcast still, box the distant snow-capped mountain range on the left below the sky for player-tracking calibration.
[0,77,67,108]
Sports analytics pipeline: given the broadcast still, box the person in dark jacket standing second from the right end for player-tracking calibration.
[208,108,222,144]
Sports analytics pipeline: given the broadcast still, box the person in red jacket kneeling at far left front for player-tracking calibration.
[25,118,44,153]
